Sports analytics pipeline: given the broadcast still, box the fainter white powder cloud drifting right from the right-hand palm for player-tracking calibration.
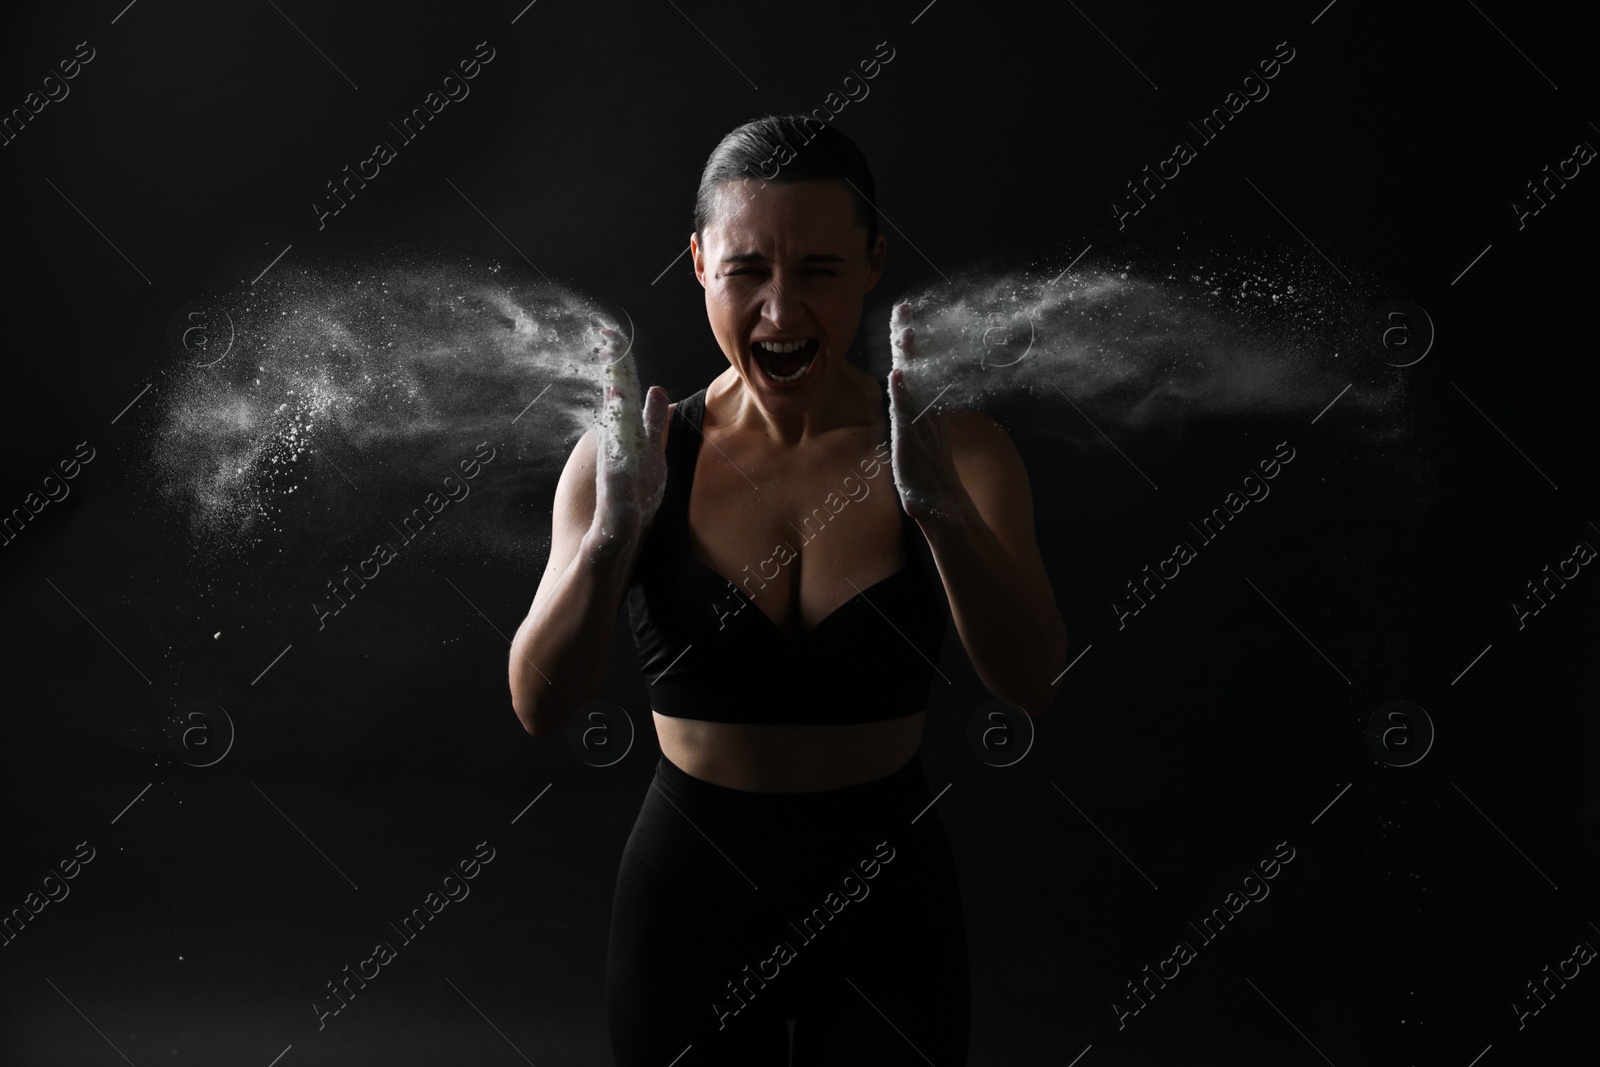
[891,250,1405,440]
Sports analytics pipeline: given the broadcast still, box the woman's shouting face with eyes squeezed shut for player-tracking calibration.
[690,179,885,414]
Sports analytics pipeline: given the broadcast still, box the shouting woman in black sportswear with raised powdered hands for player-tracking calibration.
[510,117,1066,1067]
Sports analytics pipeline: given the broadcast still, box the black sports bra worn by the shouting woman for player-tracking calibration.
[627,377,949,723]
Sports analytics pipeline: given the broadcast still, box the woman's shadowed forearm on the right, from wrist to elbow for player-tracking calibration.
[918,494,1067,715]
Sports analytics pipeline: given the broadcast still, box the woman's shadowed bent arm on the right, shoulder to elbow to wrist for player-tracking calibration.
[917,410,1067,715]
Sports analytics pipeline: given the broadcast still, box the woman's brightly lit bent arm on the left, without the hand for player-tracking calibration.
[510,430,643,737]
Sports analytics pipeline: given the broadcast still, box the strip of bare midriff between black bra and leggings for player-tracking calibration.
[653,712,926,793]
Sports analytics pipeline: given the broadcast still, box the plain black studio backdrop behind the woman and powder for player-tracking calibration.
[0,0,1600,1067]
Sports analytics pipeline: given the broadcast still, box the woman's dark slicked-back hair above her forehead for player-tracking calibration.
[694,115,878,253]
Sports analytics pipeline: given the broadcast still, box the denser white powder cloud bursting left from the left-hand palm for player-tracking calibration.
[147,261,624,579]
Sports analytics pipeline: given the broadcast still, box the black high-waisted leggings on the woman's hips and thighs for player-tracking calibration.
[606,757,971,1067]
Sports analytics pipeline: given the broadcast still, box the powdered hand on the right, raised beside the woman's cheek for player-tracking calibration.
[890,304,966,523]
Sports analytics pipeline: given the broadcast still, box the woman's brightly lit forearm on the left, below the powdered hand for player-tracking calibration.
[509,534,637,737]
